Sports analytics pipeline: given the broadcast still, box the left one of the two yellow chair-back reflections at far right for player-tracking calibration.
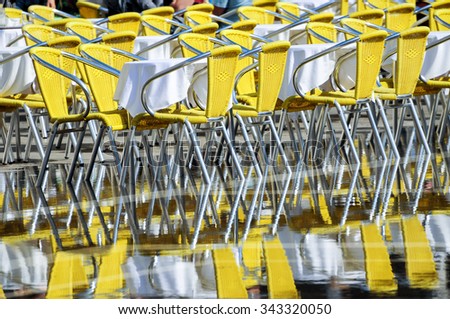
[361,224,397,291]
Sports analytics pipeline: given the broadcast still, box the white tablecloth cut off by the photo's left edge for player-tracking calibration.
[0,47,36,96]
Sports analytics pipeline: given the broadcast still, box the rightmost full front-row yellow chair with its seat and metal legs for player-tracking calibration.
[375,27,431,157]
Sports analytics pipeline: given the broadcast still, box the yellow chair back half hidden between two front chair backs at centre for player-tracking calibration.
[220,30,256,95]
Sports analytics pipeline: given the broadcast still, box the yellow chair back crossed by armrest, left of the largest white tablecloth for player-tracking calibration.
[80,44,121,112]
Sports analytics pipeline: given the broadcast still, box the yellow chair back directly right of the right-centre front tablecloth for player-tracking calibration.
[355,31,387,100]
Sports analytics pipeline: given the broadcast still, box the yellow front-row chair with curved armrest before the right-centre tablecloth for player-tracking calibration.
[282,31,387,167]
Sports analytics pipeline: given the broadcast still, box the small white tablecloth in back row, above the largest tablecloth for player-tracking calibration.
[133,35,178,59]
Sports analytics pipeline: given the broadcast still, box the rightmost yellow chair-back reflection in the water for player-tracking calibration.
[402,216,437,288]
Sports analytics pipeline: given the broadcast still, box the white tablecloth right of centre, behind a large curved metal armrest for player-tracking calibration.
[279,44,355,100]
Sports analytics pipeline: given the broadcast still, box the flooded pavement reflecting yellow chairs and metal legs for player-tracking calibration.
[0,126,450,298]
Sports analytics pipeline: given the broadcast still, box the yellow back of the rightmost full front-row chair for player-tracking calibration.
[394,27,430,95]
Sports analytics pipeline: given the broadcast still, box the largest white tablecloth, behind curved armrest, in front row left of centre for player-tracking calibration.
[114,58,206,116]
